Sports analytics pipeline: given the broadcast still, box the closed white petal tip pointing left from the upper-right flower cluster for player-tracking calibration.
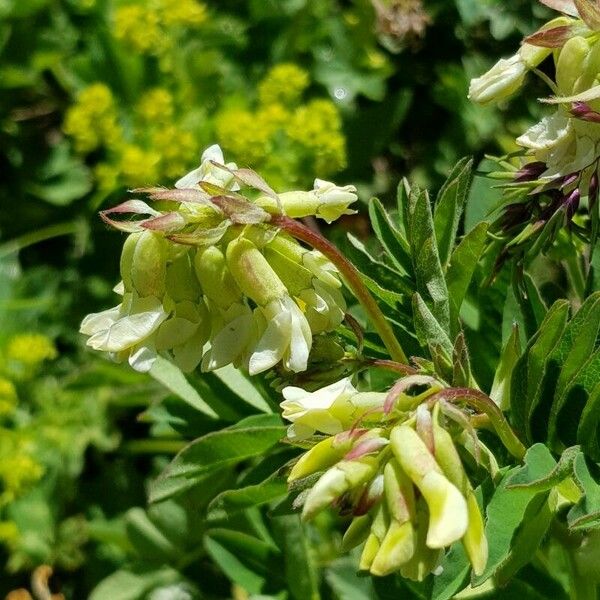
[469,53,528,104]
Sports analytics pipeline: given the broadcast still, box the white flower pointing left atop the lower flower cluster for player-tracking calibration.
[281,377,385,439]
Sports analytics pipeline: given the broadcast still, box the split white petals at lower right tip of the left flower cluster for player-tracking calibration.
[248,296,312,375]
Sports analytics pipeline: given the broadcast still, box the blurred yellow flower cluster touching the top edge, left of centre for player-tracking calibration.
[114,0,208,54]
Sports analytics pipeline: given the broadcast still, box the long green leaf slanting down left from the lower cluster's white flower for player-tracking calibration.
[149,415,285,502]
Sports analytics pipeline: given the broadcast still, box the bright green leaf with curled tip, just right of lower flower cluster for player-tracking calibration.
[474,444,556,585]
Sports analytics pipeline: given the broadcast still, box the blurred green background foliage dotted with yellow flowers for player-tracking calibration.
[0,0,548,599]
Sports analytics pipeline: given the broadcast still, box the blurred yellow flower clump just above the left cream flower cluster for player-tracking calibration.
[215,63,346,189]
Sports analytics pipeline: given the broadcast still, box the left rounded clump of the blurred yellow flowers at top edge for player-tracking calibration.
[114,4,167,54]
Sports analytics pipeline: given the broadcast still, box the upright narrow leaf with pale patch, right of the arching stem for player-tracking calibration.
[407,188,450,334]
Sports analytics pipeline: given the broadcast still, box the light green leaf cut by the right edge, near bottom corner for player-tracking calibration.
[567,454,600,530]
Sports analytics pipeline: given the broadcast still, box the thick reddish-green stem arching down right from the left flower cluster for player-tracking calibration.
[271,215,408,363]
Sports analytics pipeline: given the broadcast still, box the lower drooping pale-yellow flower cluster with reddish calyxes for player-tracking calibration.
[281,375,495,581]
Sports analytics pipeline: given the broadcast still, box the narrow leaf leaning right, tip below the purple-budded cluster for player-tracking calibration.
[446,222,489,335]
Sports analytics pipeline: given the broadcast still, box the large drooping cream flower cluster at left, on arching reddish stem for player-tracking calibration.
[81,146,356,374]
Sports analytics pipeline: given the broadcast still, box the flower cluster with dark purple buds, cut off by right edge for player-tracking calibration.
[469,0,600,246]
